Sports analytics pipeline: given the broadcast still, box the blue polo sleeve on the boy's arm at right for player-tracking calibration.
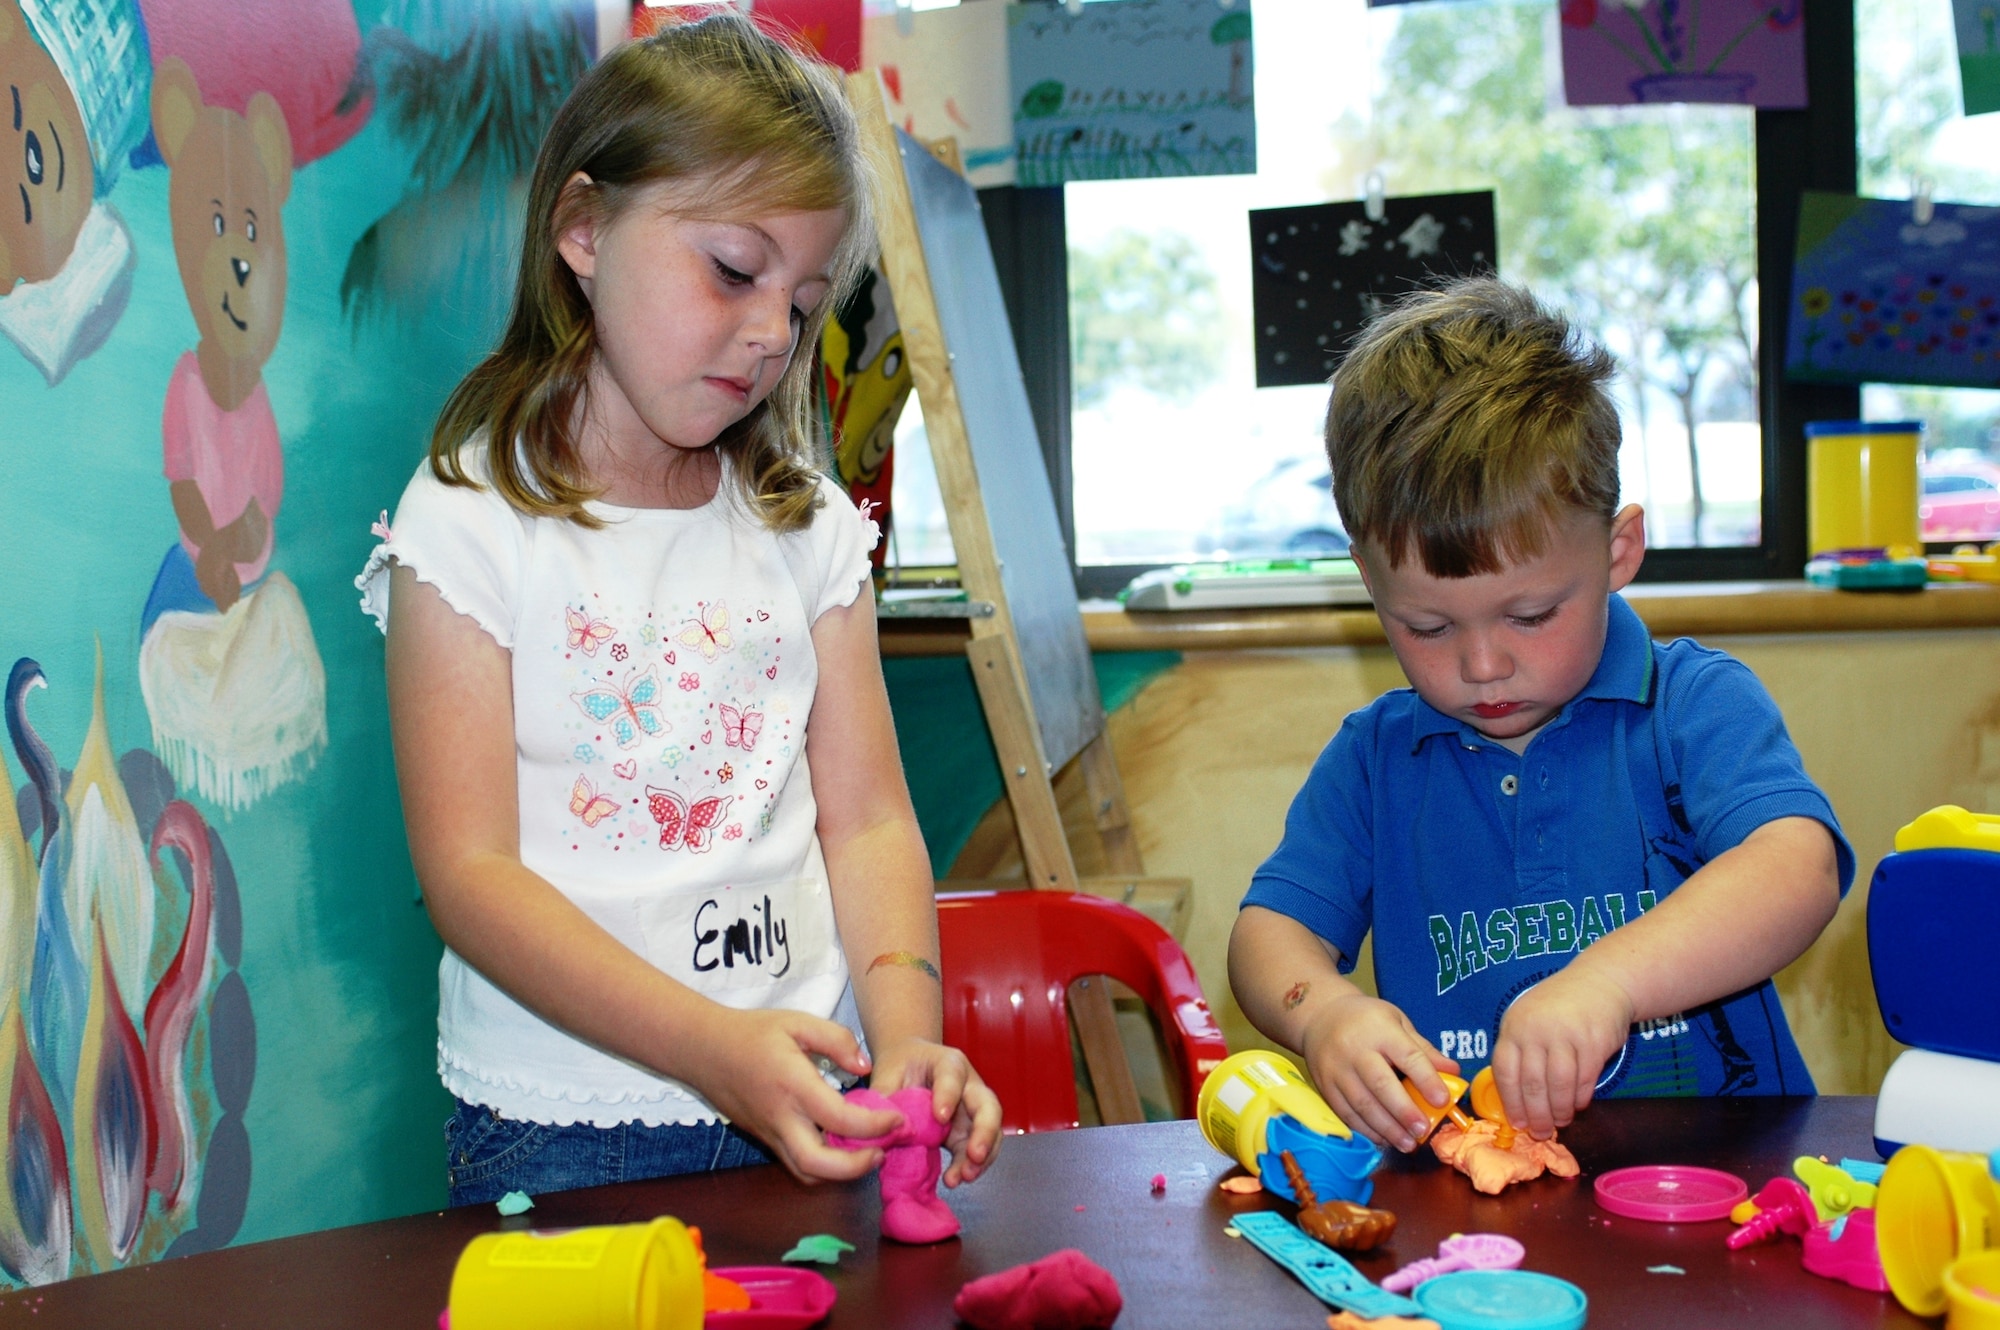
[1660,644,1854,896]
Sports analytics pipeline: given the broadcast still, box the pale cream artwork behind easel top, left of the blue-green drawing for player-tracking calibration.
[862,0,1014,188]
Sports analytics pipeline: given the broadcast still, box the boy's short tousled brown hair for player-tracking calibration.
[1326,278,1618,578]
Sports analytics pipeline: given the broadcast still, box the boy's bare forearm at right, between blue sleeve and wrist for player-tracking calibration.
[1572,818,1840,1020]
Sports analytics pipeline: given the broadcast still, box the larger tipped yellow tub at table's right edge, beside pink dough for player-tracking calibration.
[1876,1146,2000,1316]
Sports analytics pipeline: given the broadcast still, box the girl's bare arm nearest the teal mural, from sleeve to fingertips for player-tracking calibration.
[388,568,900,1178]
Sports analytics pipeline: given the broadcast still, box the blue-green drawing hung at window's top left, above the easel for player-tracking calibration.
[1016,0,1256,184]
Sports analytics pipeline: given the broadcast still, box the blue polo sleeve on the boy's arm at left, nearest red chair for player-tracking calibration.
[1244,710,1378,974]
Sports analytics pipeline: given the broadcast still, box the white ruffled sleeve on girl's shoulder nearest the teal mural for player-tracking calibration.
[354,458,528,650]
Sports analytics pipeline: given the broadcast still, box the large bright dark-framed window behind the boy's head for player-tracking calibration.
[896,0,1856,594]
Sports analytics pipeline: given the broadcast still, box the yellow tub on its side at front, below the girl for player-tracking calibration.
[452,1218,702,1330]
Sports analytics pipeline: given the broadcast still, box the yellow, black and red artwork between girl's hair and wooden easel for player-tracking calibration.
[820,268,914,572]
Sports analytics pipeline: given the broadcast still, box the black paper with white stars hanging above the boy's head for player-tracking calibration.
[1250,192,1498,388]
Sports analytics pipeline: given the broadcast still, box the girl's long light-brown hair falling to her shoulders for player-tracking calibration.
[430,14,872,532]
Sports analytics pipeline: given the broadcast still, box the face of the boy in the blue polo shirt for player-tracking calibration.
[1356,504,1646,752]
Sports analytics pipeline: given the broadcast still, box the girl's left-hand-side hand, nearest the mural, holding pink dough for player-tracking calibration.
[696,1008,902,1184]
